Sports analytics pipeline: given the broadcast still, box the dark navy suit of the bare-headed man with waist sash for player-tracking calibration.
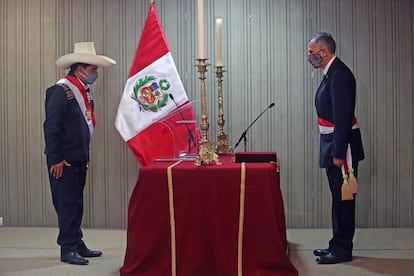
[315,57,364,256]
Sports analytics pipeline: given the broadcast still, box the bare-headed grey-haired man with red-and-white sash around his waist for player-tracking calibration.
[308,33,364,264]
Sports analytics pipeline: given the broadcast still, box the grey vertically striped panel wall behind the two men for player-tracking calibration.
[0,0,414,228]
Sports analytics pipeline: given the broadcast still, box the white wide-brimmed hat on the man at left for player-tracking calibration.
[56,42,116,69]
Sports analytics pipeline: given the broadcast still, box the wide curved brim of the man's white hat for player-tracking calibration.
[56,53,116,69]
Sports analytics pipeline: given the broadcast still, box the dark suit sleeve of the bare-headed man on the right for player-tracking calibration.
[330,70,355,160]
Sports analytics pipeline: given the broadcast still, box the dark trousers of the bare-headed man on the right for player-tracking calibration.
[326,162,358,256]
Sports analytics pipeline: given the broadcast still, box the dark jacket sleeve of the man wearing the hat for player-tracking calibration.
[43,85,68,164]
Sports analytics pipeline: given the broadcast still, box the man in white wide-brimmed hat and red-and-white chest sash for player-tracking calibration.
[43,42,116,265]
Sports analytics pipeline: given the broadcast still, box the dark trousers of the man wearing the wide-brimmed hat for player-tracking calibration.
[48,161,87,254]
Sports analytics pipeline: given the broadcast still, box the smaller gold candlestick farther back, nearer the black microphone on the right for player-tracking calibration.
[216,66,233,153]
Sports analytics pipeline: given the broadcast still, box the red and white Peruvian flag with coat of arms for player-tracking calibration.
[115,3,199,166]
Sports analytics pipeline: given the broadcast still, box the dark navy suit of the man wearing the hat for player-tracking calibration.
[43,76,93,254]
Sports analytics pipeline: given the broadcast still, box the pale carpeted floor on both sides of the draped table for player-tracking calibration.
[0,227,414,276]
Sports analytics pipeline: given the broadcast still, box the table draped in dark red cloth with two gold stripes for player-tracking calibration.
[120,155,298,276]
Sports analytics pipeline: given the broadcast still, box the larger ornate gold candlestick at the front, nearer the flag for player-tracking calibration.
[194,58,221,166]
